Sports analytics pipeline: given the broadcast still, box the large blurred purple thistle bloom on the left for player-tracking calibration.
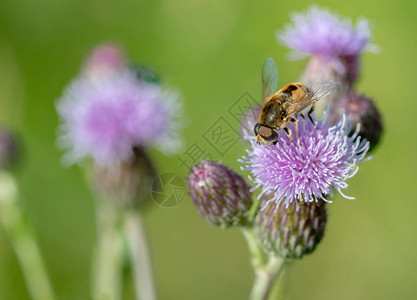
[57,71,180,166]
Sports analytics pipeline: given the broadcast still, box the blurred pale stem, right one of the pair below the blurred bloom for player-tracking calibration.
[124,211,156,300]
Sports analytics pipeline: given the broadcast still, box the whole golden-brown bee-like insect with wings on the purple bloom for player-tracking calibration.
[253,57,337,145]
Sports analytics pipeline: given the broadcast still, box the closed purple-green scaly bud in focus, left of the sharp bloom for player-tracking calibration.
[188,160,252,228]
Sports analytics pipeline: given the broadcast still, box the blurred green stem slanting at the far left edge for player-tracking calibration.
[0,171,55,300]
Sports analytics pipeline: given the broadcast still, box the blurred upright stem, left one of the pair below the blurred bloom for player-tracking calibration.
[92,199,123,300]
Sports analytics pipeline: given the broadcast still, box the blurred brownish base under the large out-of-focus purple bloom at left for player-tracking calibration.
[89,148,155,207]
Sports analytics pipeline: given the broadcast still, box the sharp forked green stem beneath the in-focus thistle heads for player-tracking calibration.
[242,228,285,300]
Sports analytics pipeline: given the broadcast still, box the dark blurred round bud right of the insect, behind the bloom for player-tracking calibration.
[330,91,383,149]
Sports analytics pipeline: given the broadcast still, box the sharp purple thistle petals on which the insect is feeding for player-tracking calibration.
[240,110,369,207]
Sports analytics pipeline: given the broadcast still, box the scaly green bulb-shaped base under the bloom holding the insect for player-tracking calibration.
[253,197,327,259]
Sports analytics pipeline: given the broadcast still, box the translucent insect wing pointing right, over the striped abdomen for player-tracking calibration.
[287,80,338,116]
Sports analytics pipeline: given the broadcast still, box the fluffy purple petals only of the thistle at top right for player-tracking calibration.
[277,6,375,59]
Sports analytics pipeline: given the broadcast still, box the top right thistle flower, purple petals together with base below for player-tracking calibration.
[277,6,377,87]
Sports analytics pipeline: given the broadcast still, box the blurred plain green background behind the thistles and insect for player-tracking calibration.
[0,0,417,300]
